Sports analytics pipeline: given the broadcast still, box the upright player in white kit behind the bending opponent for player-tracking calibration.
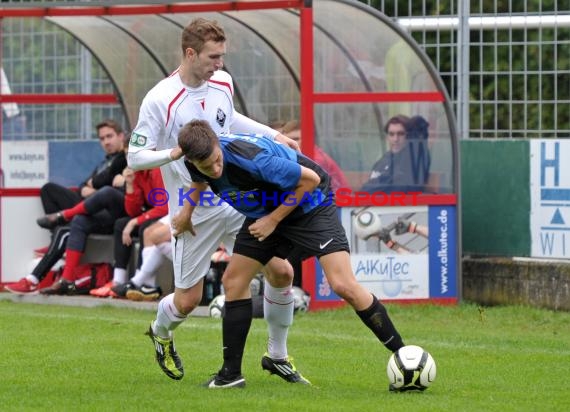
[128,18,309,384]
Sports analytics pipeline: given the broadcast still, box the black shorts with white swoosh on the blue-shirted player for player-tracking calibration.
[234,205,350,265]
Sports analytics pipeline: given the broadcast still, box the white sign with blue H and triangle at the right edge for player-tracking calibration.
[530,140,570,258]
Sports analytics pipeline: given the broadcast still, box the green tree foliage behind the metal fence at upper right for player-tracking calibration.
[361,0,570,138]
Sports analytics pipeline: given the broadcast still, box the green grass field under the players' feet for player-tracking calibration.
[0,297,570,412]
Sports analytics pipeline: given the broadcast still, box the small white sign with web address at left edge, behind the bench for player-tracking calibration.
[0,140,49,188]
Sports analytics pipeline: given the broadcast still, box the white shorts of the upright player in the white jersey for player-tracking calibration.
[172,207,245,289]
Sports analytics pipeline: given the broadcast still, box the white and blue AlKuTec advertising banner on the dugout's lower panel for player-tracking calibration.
[314,206,458,301]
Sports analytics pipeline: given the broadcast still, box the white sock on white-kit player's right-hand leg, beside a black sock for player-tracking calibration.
[263,279,294,359]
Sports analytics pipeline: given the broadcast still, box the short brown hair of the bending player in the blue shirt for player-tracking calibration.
[178,120,219,161]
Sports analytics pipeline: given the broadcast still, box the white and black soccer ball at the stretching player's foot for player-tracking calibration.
[387,345,436,391]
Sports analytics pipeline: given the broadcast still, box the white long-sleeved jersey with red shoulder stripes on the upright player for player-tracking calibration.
[128,70,276,223]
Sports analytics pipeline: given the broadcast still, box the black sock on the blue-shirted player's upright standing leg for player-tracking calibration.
[220,298,252,378]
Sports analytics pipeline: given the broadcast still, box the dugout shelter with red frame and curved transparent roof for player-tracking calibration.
[0,0,461,308]
